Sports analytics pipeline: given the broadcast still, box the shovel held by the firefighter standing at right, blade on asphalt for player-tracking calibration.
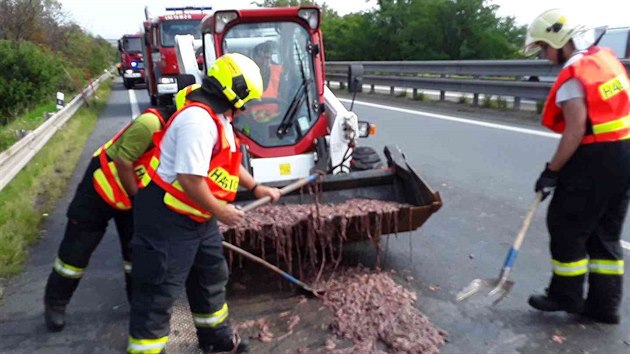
[456,192,542,305]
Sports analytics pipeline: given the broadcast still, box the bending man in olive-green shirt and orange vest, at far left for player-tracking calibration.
[44,103,177,331]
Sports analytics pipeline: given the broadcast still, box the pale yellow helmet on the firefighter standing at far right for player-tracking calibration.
[523,9,586,56]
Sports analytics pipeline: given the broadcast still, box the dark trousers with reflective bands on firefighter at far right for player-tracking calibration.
[547,141,630,313]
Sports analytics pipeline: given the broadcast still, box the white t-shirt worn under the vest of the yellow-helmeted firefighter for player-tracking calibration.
[157,107,236,183]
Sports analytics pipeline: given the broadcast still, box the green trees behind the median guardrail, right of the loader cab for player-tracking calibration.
[254,0,526,60]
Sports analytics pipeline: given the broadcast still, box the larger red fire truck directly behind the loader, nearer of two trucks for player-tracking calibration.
[143,6,212,105]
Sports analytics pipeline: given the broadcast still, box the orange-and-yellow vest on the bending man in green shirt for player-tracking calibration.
[92,108,165,210]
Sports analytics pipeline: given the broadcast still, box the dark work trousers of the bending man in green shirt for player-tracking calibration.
[44,158,133,306]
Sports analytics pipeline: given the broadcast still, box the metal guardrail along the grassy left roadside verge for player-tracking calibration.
[0,72,111,191]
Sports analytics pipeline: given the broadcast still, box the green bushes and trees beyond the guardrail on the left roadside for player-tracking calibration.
[0,0,116,124]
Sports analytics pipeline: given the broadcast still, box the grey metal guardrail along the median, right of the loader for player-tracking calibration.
[326,59,630,104]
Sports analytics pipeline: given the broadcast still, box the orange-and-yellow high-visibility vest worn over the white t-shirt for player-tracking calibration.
[148,101,242,223]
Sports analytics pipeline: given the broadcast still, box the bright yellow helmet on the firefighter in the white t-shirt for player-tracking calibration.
[208,53,263,109]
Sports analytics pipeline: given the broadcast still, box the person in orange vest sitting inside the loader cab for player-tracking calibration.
[251,41,286,123]
